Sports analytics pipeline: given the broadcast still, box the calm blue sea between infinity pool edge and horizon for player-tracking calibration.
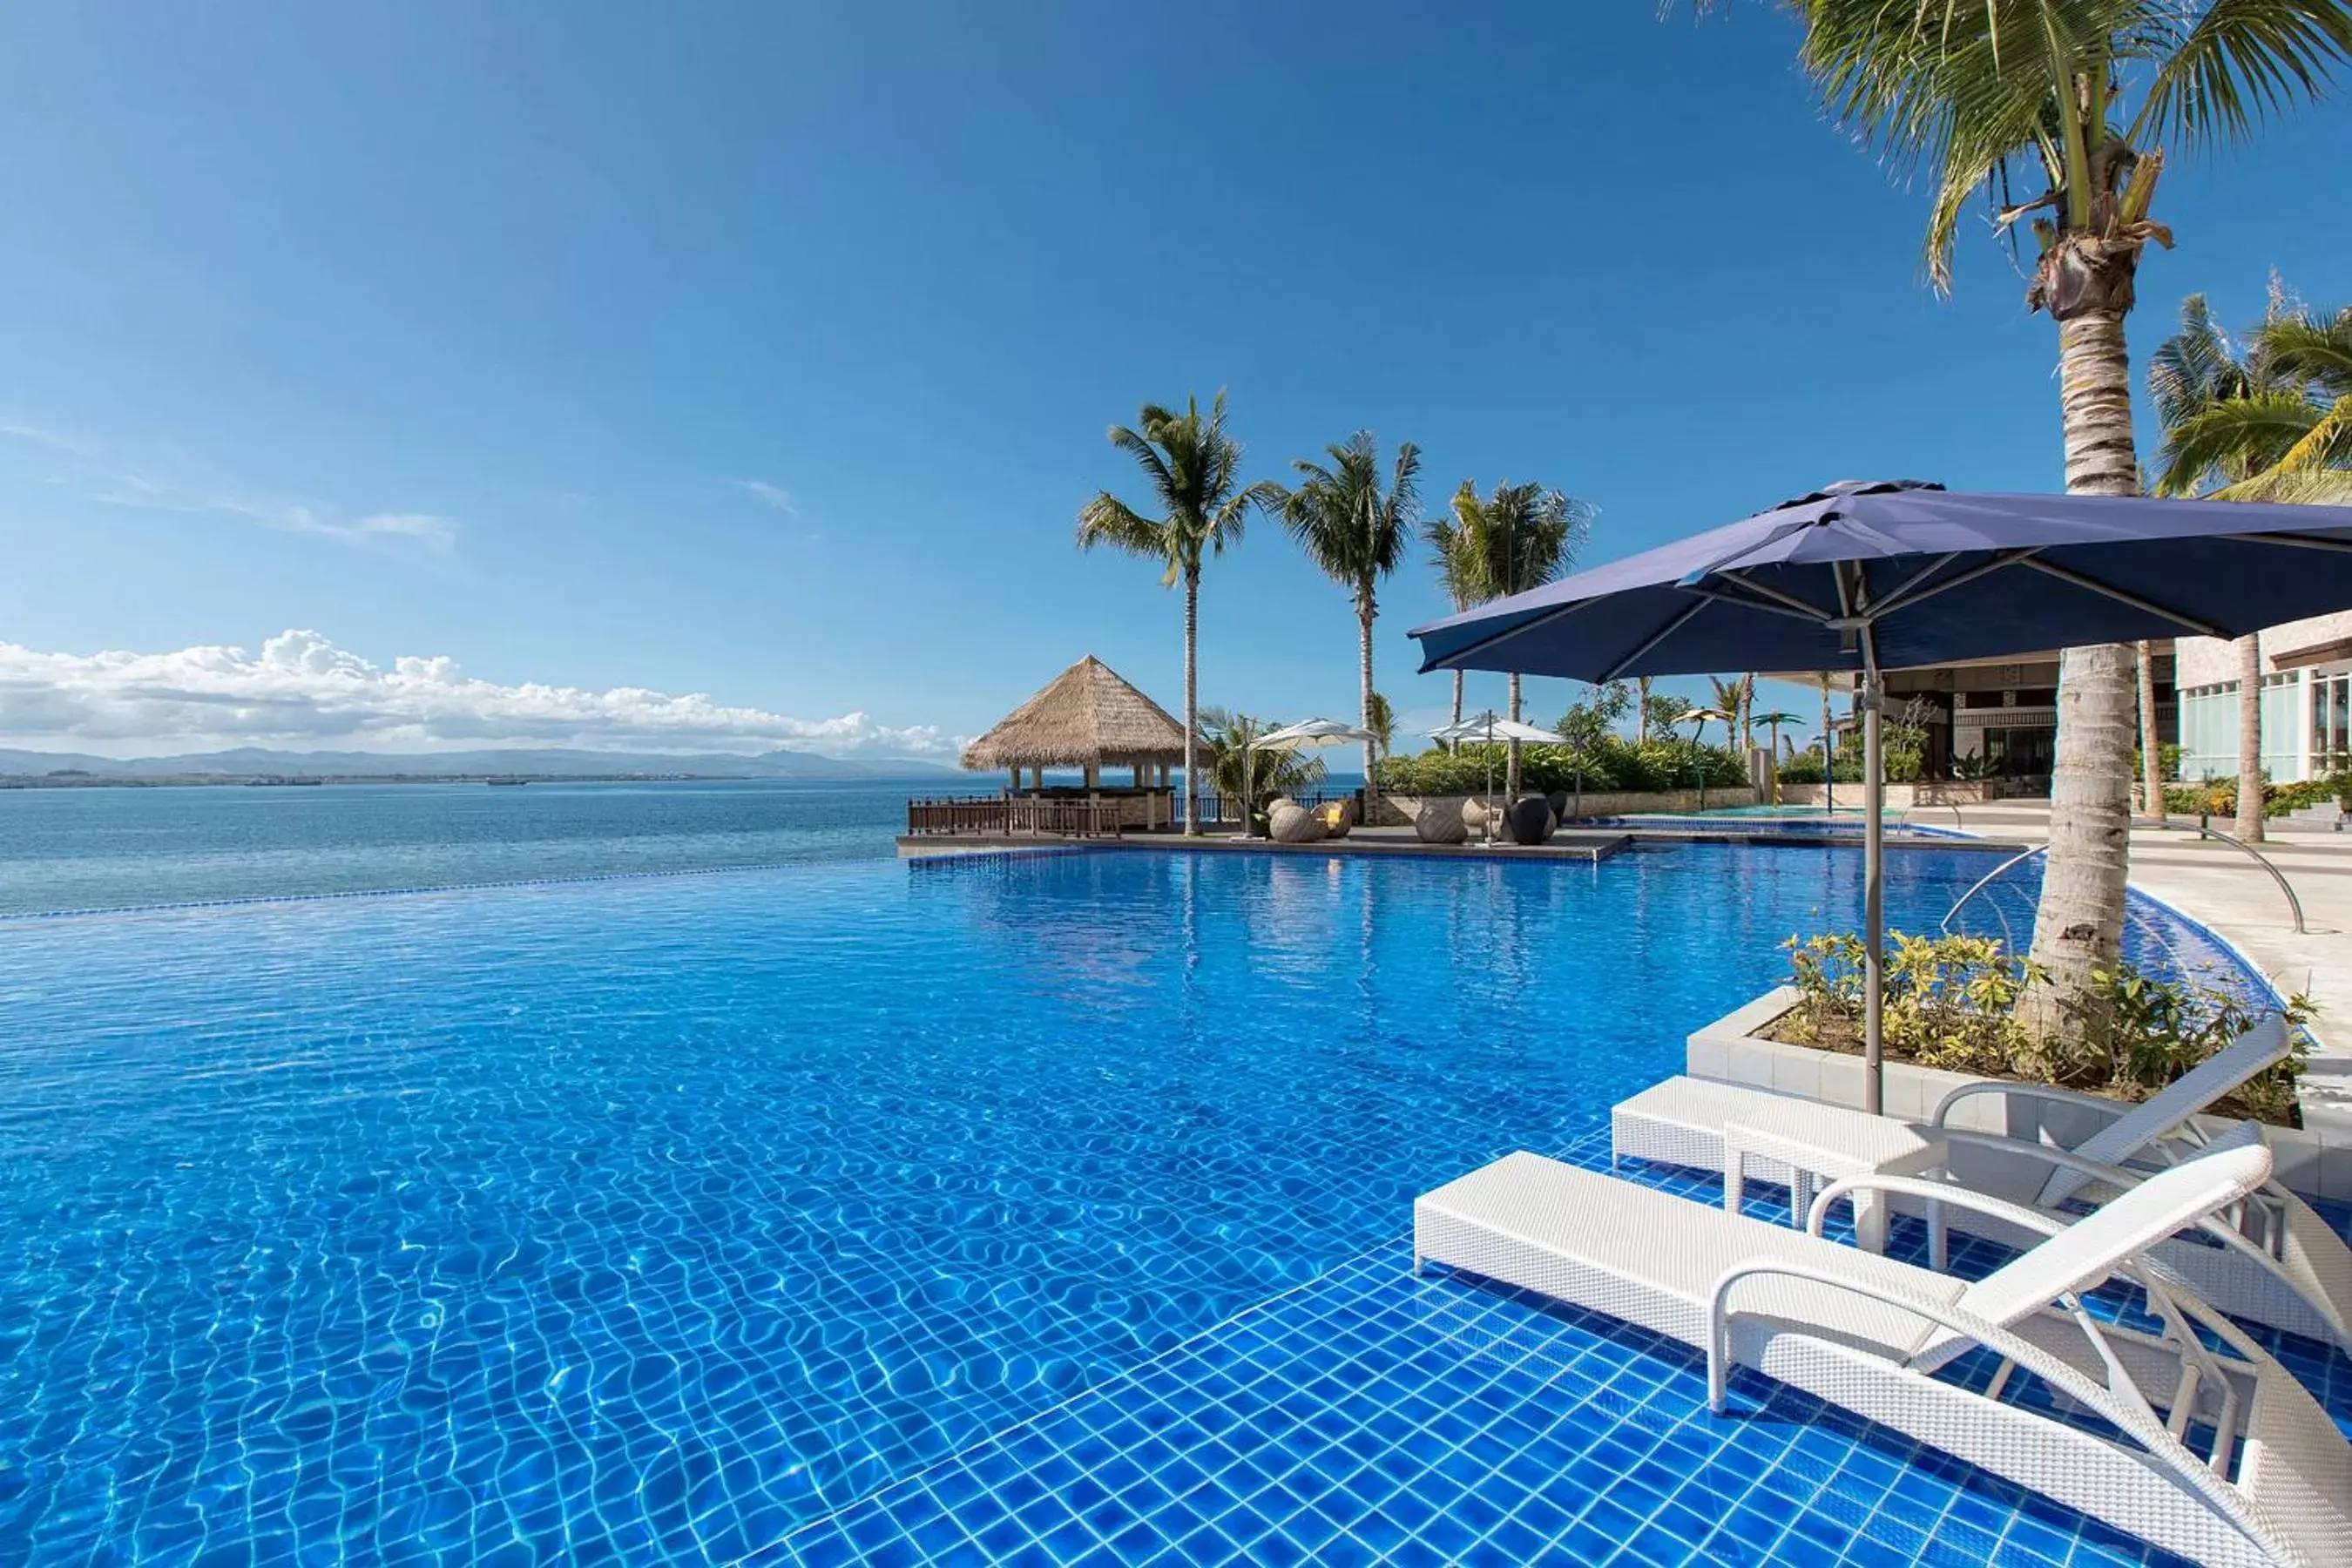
[0,778,941,915]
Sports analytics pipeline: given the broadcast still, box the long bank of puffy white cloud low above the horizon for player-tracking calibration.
[0,630,962,757]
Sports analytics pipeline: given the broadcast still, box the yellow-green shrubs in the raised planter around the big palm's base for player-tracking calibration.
[1781,931,2312,1124]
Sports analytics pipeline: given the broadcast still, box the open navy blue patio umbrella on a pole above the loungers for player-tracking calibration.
[1411,480,2352,1112]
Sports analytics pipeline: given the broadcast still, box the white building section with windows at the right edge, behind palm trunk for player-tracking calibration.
[2178,613,2352,783]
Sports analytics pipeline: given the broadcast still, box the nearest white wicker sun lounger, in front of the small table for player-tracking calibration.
[1414,1145,2352,1568]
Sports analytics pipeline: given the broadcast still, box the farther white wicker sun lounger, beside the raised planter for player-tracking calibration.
[1612,1018,2352,1352]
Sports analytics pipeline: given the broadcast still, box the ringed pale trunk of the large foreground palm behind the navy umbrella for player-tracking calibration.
[2018,305,2140,1042]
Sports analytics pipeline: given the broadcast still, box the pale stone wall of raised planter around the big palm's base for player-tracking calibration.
[1684,985,2352,1204]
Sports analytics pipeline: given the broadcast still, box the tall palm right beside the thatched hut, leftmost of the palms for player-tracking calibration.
[1078,393,1282,837]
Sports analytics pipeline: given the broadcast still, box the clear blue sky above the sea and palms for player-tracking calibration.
[0,0,2352,750]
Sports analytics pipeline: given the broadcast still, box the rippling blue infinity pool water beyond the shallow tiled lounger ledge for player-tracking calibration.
[0,844,2305,1564]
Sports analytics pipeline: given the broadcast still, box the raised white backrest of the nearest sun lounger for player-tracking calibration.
[1915,1145,2270,1370]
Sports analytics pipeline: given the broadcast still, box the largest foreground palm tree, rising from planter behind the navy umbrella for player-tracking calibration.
[1759,0,2352,1039]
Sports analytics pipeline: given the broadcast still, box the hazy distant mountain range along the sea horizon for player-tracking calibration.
[0,745,955,778]
